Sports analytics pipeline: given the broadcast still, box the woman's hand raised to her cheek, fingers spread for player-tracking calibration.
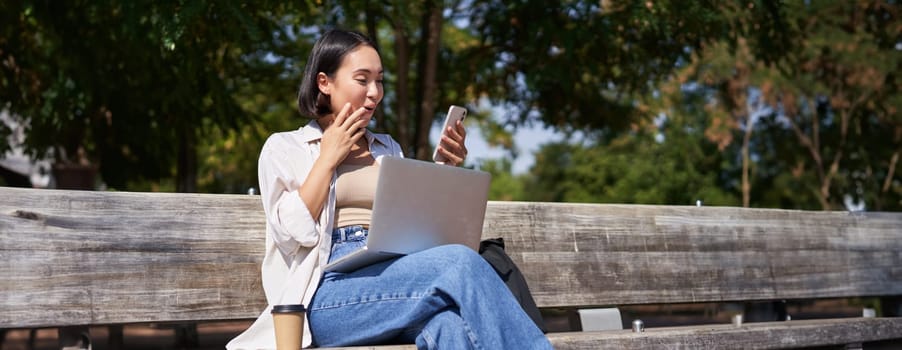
[320,103,367,167]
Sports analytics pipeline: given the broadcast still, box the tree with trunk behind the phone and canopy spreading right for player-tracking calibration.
[326,1,744,158]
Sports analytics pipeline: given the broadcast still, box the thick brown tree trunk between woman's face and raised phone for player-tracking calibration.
[416,1,442,160]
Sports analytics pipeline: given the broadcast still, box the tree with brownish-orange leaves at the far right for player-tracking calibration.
[679,2,900,210]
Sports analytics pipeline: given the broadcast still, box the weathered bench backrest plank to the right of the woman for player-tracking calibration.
[483,202,902,307]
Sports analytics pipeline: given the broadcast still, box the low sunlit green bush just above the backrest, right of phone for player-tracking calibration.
[526,97,738,205]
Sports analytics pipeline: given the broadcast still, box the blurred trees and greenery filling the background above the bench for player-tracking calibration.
[0,0,902,211]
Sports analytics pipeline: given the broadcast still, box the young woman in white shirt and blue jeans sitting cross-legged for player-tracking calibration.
[227,30,551,349]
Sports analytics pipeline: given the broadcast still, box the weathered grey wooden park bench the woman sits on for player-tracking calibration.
[0,188,902,349]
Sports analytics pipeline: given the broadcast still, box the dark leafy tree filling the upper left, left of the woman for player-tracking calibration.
[0,0,308,191]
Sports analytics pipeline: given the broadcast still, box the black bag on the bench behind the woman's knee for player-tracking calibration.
[479,238,548,333]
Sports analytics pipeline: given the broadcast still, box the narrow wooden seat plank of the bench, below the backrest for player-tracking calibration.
[324,318,902,350]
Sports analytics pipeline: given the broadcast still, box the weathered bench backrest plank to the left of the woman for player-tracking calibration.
[0,188,265,328]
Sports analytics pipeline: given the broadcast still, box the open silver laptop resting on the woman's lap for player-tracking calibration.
[324,156,491,272]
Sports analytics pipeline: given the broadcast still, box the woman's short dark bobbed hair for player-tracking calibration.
[298,29,379,118]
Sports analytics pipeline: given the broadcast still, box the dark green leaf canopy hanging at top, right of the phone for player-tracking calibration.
[464,1,727,133]
